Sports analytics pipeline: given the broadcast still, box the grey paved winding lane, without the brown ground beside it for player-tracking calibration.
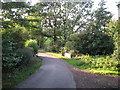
[15,53,76,88]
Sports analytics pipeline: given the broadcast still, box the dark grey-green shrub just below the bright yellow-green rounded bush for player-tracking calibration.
[17,48,34,66]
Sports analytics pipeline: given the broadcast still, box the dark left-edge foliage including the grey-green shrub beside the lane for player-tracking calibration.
[2,29,34,72]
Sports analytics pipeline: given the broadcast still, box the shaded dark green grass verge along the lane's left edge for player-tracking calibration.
[2,57,41,88]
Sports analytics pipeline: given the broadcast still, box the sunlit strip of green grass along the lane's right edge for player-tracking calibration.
[39,50,120,75]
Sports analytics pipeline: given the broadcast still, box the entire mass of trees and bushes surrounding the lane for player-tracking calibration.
[1,0,120,86]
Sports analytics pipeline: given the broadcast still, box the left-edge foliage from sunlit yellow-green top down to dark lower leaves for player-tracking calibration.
[2,25,31,72]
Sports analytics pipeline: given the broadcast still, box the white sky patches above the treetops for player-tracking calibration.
[26,0,120,19]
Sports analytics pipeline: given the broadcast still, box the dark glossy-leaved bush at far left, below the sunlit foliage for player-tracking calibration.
[2,30,22,71]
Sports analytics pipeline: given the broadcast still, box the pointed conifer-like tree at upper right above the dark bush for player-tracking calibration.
[89,0,112,34]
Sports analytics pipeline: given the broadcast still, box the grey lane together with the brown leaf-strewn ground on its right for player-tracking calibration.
[15,53,120,88]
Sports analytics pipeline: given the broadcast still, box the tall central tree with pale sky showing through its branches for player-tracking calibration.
[32,1,92,51]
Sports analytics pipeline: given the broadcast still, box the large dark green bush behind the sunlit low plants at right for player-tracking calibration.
[82,33,114,55]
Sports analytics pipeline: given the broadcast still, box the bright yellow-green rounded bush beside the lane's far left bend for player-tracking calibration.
[25,39,39,54]
